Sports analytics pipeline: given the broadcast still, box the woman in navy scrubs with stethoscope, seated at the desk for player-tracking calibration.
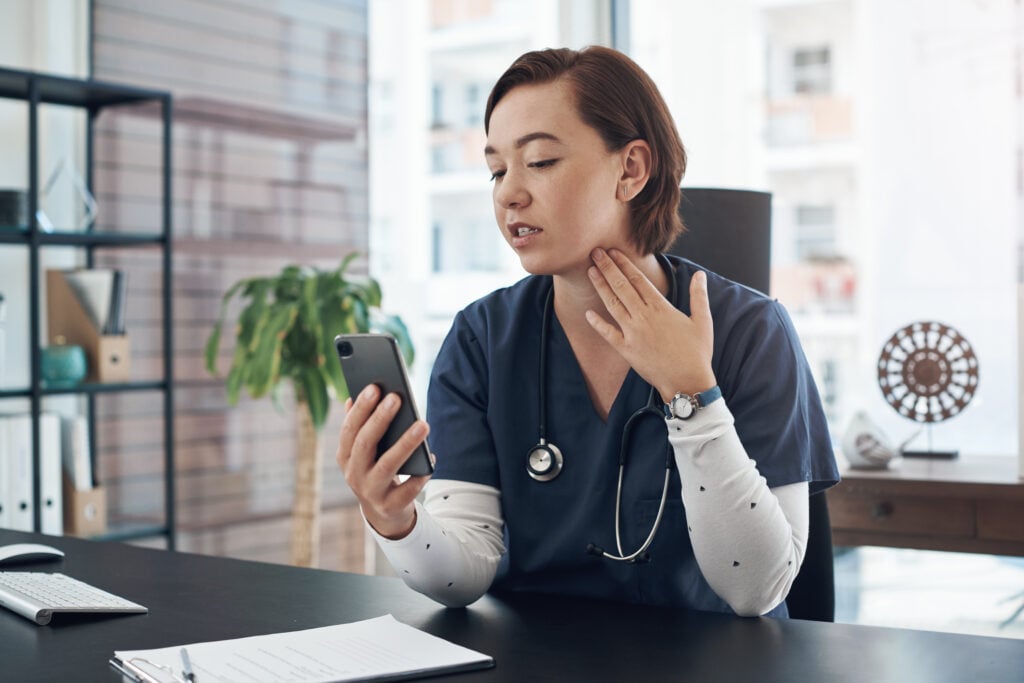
[338,47,838,615]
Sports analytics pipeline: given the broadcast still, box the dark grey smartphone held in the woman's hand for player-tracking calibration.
[334,334,434,475]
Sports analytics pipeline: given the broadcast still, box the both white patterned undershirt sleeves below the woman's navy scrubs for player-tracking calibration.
[368,400,808,616]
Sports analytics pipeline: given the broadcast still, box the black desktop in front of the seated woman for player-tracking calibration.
[0,530,1024,683]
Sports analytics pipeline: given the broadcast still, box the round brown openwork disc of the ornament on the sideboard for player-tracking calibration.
[879,322,978,423]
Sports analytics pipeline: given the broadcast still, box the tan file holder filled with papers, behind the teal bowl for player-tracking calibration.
[46,269,131,382]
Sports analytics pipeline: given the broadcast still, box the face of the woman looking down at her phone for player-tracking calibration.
[484,81,635,275]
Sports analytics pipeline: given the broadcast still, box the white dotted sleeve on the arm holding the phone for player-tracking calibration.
[367,479,505,607]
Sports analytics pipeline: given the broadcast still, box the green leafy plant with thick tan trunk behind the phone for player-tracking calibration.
[205,253,414,566]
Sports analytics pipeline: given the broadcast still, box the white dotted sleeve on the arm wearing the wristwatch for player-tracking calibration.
[667,400,809,616]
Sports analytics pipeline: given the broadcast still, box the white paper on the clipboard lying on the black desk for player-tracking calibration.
[115,614,495,683]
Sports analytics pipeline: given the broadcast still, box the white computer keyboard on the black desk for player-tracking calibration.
[0,571,150,626]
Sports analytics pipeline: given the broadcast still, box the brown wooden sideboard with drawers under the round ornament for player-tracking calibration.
[827,456,1024,556]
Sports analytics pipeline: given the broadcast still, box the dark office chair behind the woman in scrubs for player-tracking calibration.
[668,187,836,622]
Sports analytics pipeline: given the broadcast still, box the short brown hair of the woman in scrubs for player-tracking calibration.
[483,45,686,254]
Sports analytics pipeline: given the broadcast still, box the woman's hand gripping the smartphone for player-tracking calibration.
[336,384,430,539]
